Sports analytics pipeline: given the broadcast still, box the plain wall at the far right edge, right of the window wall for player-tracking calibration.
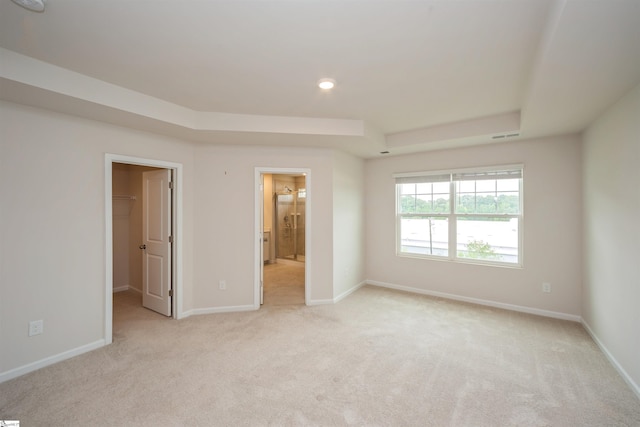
[582,86,640,396]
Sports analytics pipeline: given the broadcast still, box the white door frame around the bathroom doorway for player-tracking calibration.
[253,167,313,310]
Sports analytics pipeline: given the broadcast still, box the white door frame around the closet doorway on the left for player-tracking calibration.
[104,153,183,344]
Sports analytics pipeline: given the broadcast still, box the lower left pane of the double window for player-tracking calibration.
[400,217,449,256]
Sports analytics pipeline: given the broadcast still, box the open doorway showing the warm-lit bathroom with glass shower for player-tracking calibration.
[256,168,311,306]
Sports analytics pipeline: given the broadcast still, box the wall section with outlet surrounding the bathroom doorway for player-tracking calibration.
[194,145,333,310]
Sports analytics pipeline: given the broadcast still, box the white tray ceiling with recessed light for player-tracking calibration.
[0,0,640,158]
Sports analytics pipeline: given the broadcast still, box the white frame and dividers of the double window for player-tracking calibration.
[393,164,524,268]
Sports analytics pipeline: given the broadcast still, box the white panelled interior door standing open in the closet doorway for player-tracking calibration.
[140,169,172,316]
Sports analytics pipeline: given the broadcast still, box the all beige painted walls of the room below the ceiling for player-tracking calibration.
[8,88,640,392]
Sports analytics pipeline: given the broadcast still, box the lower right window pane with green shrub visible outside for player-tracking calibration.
[456,217,519,264]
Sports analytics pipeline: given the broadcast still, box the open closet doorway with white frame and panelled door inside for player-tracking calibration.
[105,154,182,344]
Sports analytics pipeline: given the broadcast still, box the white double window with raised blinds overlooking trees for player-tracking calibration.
[394,166,523,265]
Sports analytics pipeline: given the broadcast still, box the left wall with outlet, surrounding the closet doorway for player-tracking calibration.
[0,102,194,378]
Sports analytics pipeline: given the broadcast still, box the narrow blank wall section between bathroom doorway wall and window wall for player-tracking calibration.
[333,152,365,298]
